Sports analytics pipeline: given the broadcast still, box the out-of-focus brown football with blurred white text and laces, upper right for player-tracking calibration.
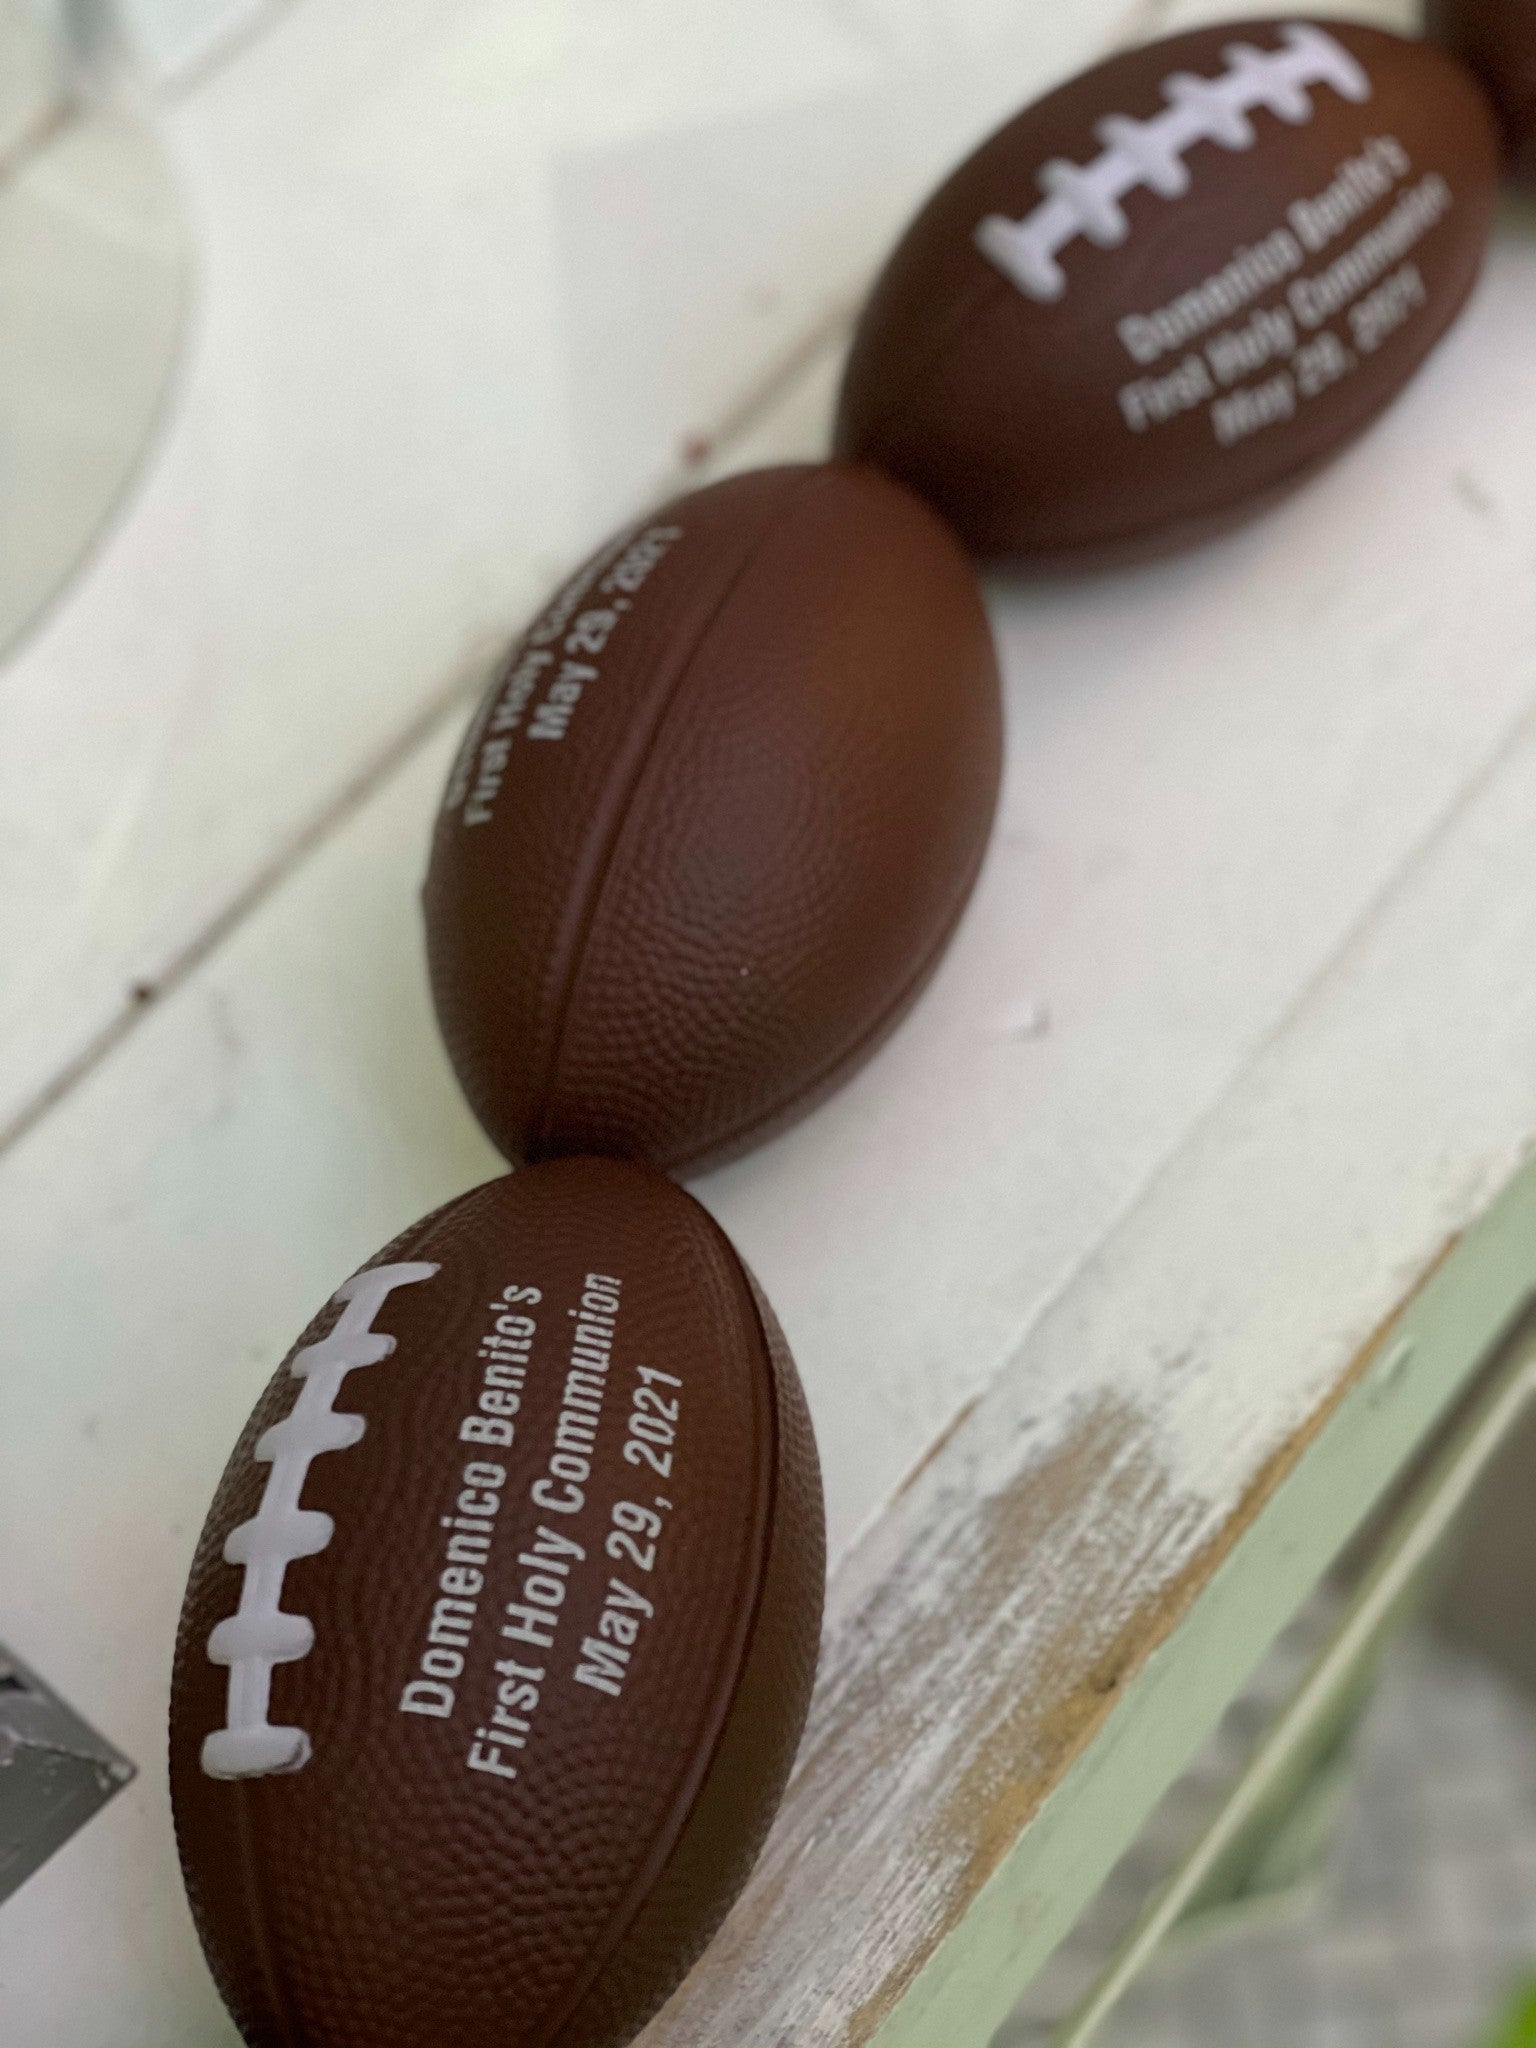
[836,20,1499,565]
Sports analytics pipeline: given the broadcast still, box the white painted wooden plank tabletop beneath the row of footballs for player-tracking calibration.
[0,0,1536,2048]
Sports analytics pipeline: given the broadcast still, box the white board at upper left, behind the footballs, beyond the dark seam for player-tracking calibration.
[0,0,1126,1143]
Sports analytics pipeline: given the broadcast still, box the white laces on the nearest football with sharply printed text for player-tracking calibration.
[203,1264,438,1778]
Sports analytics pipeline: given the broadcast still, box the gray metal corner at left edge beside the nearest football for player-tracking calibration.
[0,1642,133,1905]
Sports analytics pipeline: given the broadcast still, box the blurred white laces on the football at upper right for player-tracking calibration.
[975,23,1370,305]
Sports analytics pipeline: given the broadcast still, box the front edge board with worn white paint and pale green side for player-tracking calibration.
[647,717,1536,2048]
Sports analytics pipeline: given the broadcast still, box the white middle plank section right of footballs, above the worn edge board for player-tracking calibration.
[711,233,1536,1564]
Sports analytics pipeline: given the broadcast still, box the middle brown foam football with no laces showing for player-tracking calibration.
[424,465,1001,1167]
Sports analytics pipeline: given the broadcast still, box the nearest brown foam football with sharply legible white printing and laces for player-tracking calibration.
[170,1159,823,2048]
